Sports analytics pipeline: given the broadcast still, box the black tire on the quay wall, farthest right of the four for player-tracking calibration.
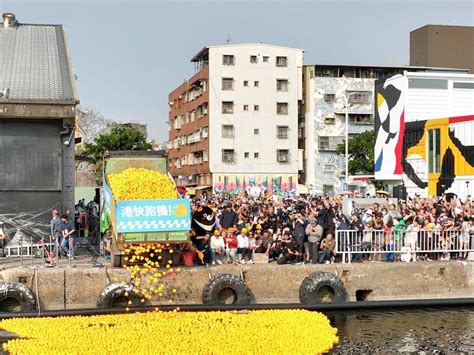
[299,272,347,304]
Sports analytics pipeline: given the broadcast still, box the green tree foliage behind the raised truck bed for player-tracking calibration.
[84,125,151,163]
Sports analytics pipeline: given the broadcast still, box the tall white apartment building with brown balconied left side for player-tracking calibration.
[168,43,303,197]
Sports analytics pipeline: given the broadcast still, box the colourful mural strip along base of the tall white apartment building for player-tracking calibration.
[213,174,297,195]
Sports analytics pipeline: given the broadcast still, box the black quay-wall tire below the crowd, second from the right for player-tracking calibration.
[202,274,251,305]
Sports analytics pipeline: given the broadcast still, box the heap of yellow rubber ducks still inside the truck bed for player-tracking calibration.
[108,168,177,201]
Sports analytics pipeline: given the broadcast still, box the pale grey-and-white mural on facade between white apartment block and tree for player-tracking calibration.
[313,77,374,192]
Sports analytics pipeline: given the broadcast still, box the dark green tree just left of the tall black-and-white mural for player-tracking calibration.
[337,131,375,175]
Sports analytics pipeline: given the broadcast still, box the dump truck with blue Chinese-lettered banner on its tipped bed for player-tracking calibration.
[101,151,191,267]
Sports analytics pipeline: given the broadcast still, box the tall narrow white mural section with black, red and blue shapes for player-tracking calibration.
[374,75,405,180]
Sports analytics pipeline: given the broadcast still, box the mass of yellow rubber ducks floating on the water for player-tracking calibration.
[0,310,339,355]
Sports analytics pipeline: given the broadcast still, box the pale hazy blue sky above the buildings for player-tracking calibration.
[0,0,474,142]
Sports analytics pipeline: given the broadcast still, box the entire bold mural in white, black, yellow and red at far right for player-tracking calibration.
[374,75,474,196]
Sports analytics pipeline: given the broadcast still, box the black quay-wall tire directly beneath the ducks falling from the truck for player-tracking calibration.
[97,282,150,308]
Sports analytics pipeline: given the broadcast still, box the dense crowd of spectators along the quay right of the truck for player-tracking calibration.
[186,196,474,265]
